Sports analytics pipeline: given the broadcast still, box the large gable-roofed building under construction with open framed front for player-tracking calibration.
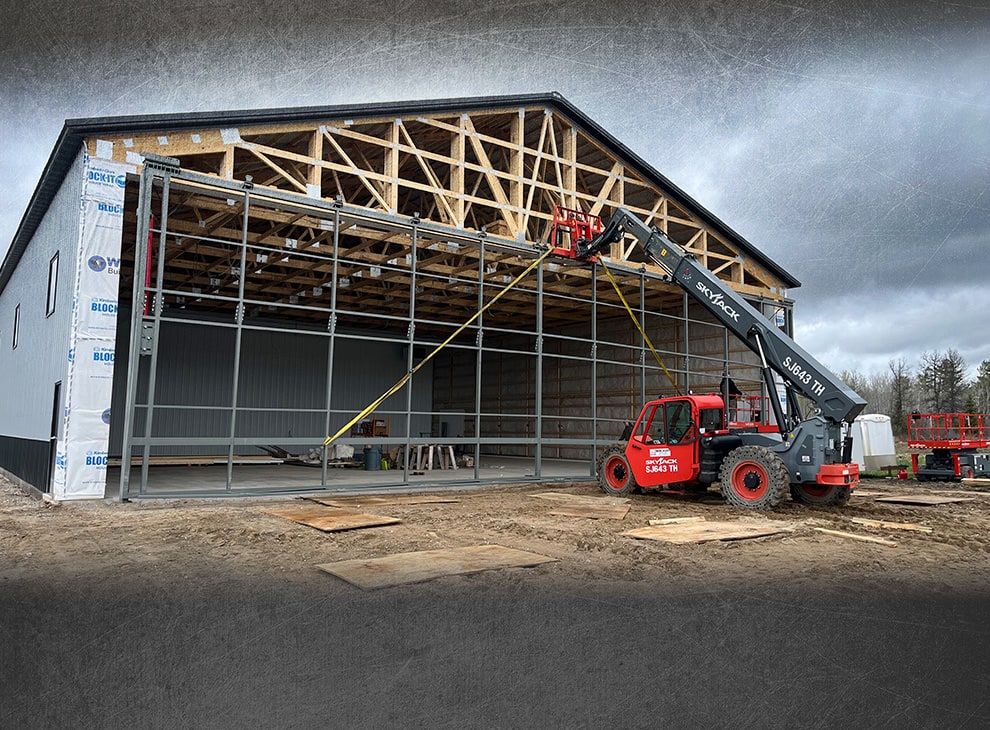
[0,94,798,499]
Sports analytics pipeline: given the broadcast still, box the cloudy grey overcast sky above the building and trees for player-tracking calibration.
[0,0,990,373]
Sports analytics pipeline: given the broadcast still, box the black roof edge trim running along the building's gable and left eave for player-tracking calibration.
[0,92,801,292]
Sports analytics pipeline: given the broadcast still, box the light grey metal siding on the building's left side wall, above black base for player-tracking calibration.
[0,148,83,438]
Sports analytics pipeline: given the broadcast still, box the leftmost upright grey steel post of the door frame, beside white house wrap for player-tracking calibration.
[117,163,155,502]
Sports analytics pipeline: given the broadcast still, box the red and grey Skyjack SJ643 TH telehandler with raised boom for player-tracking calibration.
[574,207,866,509]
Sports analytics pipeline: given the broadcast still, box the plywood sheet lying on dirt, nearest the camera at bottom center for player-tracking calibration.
[316,545,557,590]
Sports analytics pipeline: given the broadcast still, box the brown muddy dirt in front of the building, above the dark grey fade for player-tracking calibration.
[0,470,990,588]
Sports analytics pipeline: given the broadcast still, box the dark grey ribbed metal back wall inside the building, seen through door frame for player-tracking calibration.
[110,320,433,455]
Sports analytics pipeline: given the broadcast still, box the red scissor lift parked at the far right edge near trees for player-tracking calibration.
[907,413,990,479]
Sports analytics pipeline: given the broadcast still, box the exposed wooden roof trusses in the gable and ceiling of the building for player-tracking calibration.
[95,106,783,336]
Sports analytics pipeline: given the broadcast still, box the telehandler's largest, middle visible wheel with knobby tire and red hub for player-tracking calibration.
[719,446,790,509]
